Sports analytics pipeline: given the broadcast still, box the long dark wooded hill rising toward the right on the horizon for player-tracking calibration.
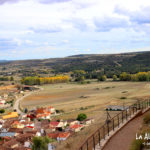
[0,52,150,75]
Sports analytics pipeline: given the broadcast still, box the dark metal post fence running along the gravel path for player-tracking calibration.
[79,99,150,150]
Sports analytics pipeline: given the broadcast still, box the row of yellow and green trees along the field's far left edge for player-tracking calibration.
[21,76,69,85]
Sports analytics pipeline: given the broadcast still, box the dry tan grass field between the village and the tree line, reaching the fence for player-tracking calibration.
[21,81,150,150]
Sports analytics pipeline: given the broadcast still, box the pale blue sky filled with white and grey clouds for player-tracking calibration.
[0,0,150,60]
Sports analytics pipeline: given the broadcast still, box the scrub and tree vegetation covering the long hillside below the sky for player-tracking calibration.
[0,52,150,78]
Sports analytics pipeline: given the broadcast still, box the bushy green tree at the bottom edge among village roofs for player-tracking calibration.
[32,136,54,150]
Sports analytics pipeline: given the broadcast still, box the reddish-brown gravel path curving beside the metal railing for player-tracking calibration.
[104,112,146,150]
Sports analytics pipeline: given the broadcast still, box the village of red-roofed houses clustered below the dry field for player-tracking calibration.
[0,87,94,150]
